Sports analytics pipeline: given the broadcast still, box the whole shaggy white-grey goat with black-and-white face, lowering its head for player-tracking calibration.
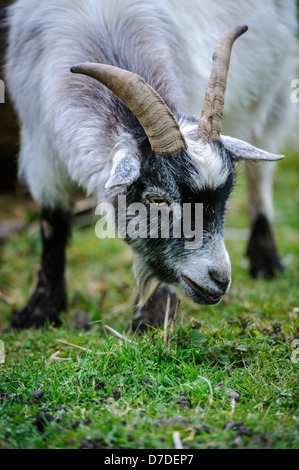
[5,0,296,328]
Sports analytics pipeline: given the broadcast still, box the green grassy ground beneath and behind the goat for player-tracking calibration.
[0,155,299,449]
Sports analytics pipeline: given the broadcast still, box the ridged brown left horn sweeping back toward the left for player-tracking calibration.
[71,63,187,153]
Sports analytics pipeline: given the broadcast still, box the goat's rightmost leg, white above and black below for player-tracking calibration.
[246,163,283,279]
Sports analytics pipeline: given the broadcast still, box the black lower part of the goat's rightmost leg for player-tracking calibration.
[246,214,284,279]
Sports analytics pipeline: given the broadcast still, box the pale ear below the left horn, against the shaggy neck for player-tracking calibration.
[105,151,140,189]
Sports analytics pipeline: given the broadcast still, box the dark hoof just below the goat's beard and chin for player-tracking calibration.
[132,286,177,333]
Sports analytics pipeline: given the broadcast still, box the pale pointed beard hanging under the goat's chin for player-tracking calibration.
[133,255,161,307]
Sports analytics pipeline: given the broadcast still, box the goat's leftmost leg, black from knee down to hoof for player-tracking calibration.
[11,208,71,328]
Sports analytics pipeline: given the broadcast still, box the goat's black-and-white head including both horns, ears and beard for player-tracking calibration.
[71,26,283,304]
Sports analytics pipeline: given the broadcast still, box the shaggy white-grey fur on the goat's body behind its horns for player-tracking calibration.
[6,0,296,208]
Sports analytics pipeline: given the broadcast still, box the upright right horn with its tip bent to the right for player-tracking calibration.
[198,25,248,142]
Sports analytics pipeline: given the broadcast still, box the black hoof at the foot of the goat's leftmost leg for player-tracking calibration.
[10,289,61,329]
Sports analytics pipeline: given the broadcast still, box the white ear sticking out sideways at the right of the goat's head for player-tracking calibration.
[220,135,285,162]
